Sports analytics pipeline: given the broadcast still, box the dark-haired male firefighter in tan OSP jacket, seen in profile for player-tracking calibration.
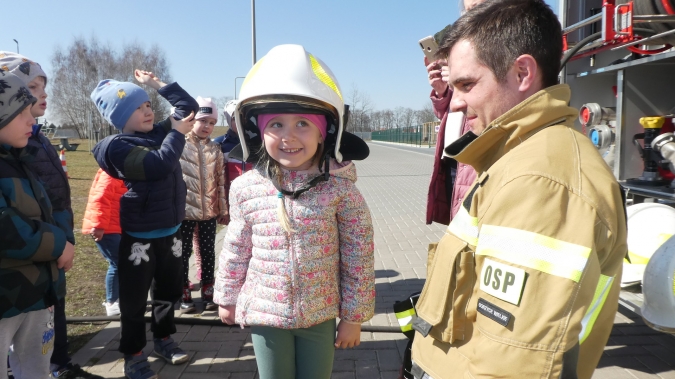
[412,0,627,379]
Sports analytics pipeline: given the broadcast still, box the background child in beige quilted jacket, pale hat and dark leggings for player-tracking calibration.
[180,96,227,313]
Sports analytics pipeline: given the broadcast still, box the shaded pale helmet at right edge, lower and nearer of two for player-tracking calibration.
[641,237,675,334]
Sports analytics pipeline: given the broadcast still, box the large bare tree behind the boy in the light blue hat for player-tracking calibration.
[48,37,171,137]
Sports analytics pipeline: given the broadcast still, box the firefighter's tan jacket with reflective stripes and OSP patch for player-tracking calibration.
[412,85,627,379]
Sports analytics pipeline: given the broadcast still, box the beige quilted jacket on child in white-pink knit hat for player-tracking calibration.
[180,132,227,221]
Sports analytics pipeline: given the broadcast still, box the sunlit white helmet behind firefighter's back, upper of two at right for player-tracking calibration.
[621,203,675,287]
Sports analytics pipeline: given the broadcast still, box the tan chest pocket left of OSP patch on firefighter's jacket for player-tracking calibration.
[413,233,474,343]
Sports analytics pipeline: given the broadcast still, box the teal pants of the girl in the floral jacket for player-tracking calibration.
[251,319,335,379]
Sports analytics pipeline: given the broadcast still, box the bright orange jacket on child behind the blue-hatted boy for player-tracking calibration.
[82,168,127,234]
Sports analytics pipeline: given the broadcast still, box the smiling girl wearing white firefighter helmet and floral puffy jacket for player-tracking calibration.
[214,45,375,379]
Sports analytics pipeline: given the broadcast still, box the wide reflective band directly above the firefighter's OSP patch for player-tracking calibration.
[476,225,591,283]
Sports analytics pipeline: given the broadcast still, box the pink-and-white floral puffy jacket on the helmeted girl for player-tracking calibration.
[214,162,375,329]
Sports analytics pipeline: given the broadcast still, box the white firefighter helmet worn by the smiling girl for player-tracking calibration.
[231,45,368,162]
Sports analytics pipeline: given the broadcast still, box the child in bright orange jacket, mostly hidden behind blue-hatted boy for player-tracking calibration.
[82,168,127,316]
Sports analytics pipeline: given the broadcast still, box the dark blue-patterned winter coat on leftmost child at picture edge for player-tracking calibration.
[0,145,67,319]
